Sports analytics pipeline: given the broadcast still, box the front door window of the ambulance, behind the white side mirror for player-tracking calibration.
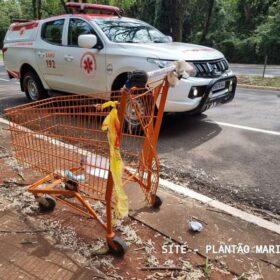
[68,18,96,47]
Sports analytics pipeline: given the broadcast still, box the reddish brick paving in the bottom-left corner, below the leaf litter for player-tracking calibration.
[0,211,100,280]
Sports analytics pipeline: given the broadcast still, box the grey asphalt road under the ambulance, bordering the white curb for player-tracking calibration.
[0,66,280,217]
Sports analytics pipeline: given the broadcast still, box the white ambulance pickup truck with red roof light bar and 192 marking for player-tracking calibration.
[3,3,237,121]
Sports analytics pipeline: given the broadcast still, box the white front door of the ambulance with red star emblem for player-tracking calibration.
[53,17,106,94]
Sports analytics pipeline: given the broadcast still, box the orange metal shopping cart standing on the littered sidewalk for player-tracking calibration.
[6,64,185,255]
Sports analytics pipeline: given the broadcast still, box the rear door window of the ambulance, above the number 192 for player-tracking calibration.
[41,19,64,45]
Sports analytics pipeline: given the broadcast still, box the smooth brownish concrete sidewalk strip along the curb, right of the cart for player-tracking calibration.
[126,187,280,279]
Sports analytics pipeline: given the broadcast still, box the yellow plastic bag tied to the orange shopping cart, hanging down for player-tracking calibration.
[102,101,128,221]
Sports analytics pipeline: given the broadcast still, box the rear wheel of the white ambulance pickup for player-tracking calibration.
[23,72,48,101]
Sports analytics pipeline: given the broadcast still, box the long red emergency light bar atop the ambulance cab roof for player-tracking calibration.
[66,2,122,17]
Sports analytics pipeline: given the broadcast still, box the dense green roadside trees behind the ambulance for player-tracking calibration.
[0,0,280,64]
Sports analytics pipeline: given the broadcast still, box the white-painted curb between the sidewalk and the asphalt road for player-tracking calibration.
[0,118,280,235]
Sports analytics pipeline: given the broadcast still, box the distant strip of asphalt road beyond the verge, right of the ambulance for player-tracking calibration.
[230,64,280,77]
